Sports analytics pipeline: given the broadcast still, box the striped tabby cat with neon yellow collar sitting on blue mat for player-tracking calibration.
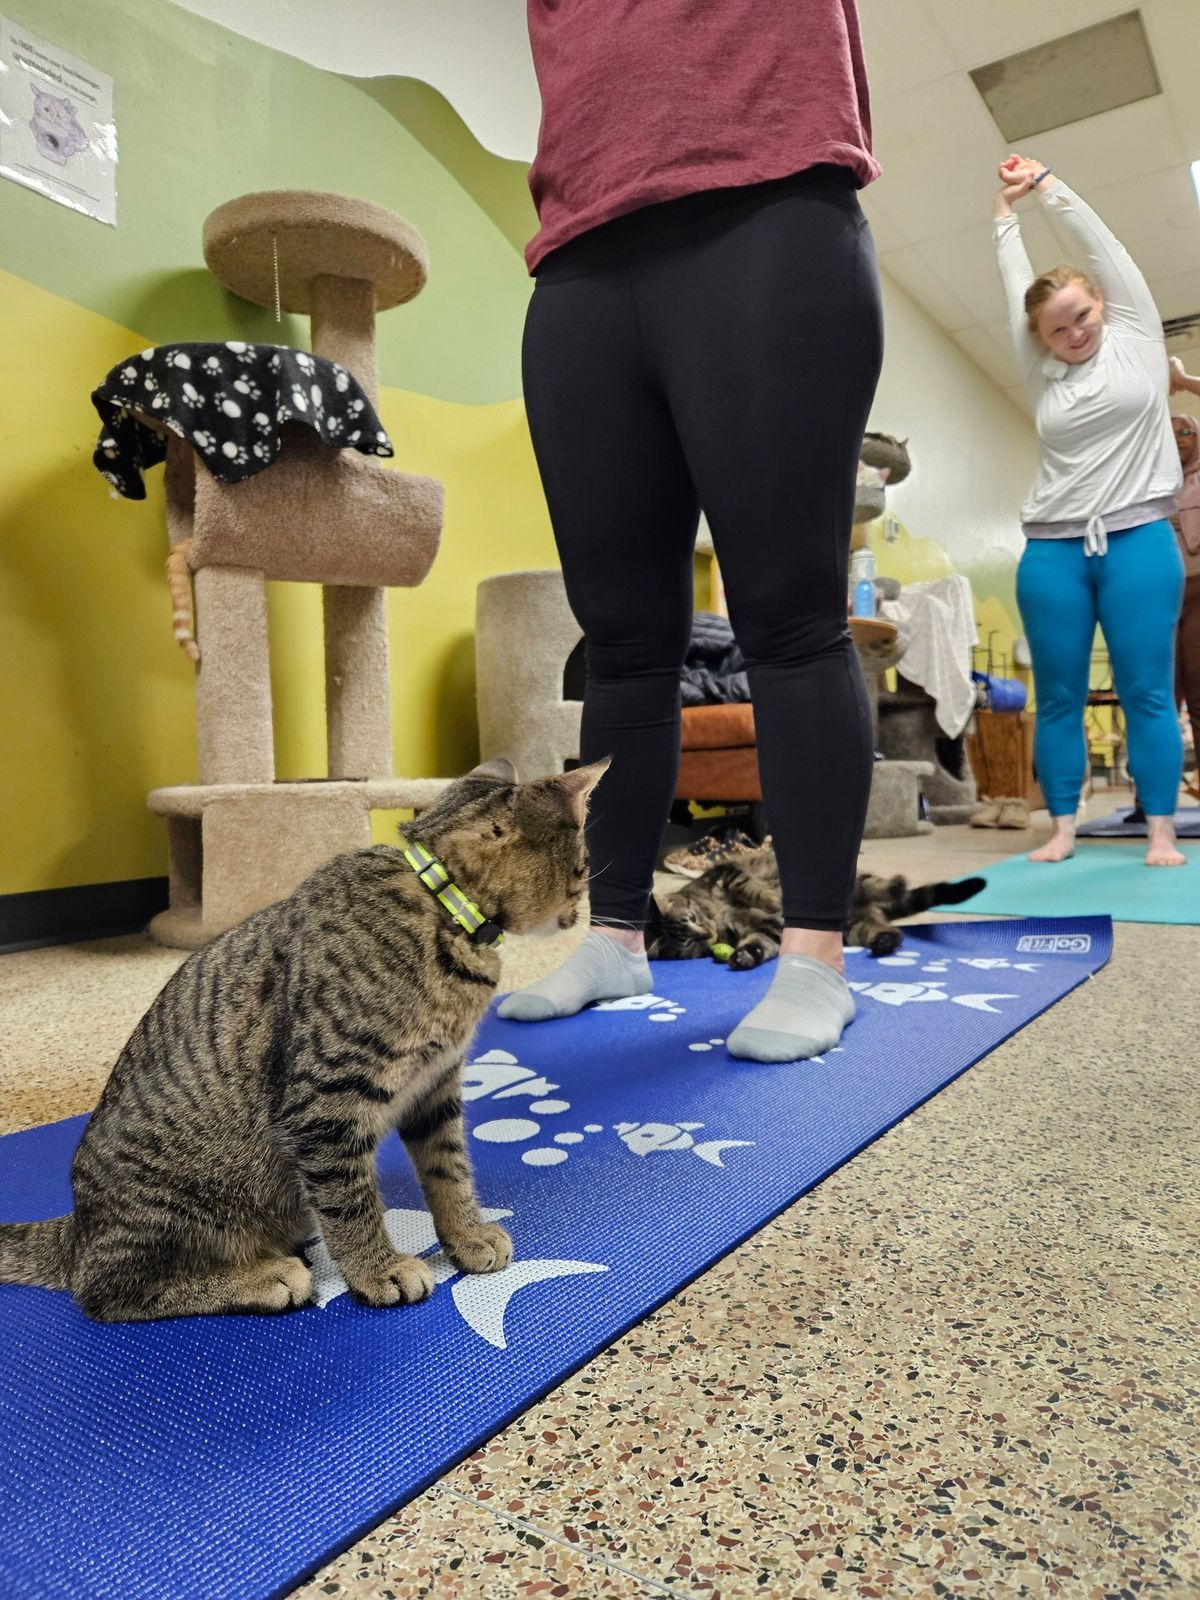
[0,762,608,1322]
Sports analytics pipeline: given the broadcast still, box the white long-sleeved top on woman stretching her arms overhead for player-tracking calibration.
[995,181,1182,539]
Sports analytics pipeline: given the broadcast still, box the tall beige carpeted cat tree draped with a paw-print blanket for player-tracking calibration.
[96,190,445,949]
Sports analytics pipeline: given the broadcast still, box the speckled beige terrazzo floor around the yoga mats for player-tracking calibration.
[0,792,1200,1600]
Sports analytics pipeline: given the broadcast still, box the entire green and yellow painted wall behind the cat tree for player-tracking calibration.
[0,0,555,894]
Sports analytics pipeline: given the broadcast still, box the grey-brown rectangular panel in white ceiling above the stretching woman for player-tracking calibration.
[971,11,1162,144]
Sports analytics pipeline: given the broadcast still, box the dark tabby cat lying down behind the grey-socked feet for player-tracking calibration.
[646,850,984,968]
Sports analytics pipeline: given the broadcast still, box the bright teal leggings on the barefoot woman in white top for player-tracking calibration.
[1016,522,1184,816]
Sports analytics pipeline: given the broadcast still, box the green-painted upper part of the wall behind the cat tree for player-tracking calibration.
[0,0,534,405]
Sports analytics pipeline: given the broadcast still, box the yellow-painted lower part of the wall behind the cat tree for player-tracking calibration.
[0,272,555,894]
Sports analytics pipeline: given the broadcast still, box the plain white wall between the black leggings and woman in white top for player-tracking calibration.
[870,275,1037,574]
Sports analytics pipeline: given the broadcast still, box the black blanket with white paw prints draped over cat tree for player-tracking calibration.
[91,339,392,499]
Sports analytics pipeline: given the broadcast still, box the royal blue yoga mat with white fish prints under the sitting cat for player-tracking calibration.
[0,918,1112,1600]
